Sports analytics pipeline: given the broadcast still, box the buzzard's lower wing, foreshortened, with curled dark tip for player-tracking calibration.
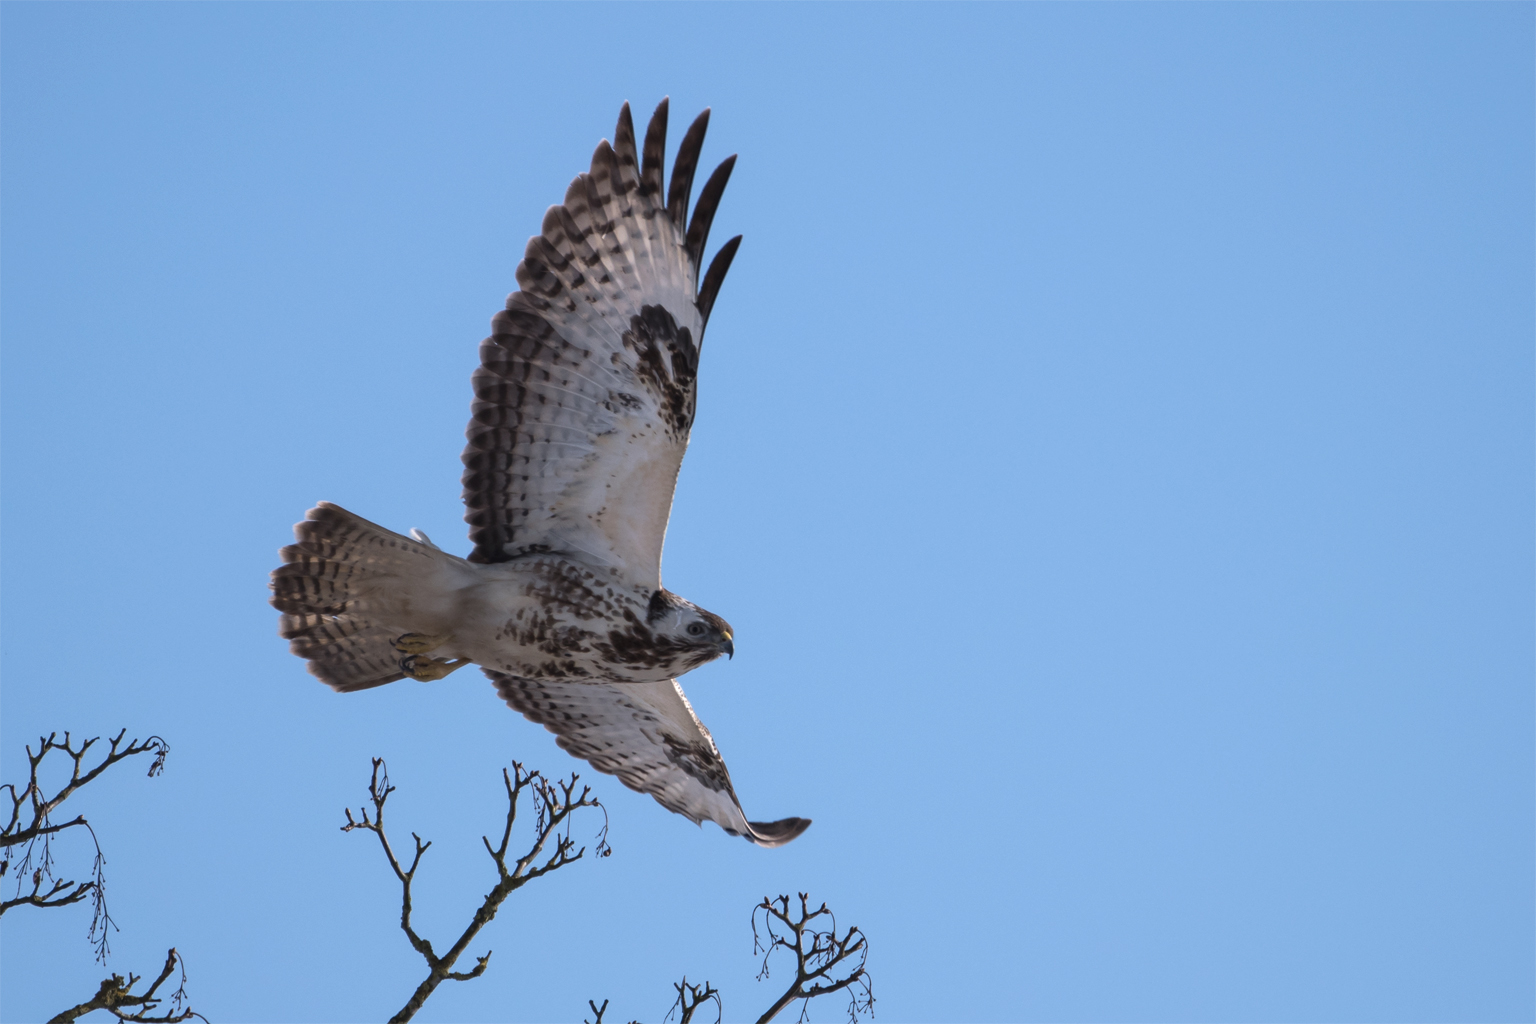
[485,669,811,846]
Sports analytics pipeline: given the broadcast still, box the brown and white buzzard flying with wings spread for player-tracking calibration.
[272,100,811,846]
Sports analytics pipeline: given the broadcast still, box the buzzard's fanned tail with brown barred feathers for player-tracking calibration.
[272,502,452,692]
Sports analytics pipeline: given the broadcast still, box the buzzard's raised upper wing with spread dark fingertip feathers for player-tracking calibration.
[464,100,740,588]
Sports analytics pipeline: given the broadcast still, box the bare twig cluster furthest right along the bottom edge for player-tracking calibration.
[753,892,874,1024]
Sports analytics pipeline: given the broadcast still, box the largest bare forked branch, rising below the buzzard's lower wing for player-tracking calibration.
[341,757,611,1024]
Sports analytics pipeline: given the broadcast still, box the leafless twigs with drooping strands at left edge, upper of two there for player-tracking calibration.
[0,729,170,964]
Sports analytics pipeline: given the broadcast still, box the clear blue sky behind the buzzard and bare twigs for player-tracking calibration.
[0,3,1536,1022]
